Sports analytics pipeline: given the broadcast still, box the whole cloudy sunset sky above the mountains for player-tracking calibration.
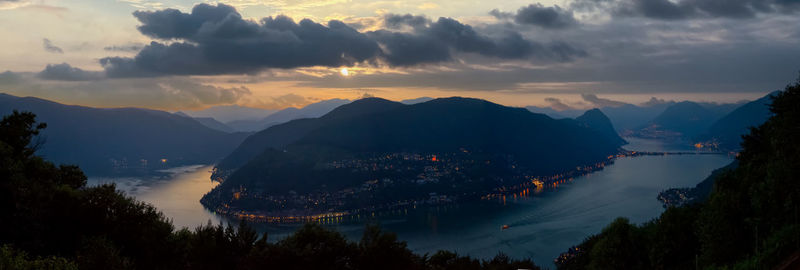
[0,0,800,110]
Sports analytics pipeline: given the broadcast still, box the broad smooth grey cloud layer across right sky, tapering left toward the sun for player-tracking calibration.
[292,26,800,94]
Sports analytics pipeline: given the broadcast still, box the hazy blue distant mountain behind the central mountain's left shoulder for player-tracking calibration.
[226,98,350,131]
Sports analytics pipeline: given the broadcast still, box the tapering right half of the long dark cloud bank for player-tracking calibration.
[368,14,587,66]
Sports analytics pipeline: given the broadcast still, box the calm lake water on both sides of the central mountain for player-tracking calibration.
[90,138,732,268]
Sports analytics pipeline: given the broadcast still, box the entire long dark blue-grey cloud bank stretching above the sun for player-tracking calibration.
[100,4,586,77]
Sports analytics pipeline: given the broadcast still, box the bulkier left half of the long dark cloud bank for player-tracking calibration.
[100,4,380,77]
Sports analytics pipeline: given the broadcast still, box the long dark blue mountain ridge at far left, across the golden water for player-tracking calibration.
[0,94,246,175]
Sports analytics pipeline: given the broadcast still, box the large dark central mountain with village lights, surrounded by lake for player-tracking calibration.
[201,98,621,216]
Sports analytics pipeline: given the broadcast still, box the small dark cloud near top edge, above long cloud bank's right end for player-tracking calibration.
[496,3,578,29]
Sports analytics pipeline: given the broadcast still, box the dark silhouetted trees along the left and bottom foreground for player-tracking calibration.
[0,112,538,270]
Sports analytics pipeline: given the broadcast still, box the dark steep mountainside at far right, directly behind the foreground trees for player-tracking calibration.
[700,91,780,150]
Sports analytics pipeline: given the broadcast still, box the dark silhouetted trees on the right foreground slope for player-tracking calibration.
[557,80,800,269]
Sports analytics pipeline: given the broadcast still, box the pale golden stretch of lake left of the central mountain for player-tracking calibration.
[89,165,222,228]
